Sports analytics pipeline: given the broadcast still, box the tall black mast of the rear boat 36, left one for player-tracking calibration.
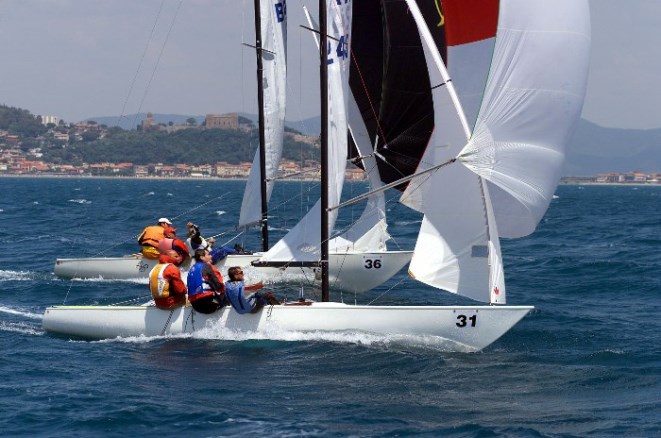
[255,0,269,251]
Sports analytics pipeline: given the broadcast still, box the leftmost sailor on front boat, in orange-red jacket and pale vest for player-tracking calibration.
[149,249,186,310]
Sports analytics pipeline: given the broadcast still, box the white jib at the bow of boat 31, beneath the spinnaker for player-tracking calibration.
[402,0,505,303]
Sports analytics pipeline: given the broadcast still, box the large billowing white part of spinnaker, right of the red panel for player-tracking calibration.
[461,0,590,237]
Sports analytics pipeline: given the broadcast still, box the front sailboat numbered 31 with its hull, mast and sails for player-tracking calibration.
[43,0,590,351]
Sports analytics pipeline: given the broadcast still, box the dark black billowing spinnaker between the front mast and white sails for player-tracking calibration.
[350,0,445,189]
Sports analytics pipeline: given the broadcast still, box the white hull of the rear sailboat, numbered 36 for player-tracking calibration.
[54,251,412,293]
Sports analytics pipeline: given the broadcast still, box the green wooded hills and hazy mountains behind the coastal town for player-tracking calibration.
[0,105,661,176]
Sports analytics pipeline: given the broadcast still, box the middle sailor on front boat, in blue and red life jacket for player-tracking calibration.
[188,249,228,313]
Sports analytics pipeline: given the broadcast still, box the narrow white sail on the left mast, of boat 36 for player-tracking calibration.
[239,0,287,227]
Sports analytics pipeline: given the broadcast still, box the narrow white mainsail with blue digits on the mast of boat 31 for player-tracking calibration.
[262,1,351,261]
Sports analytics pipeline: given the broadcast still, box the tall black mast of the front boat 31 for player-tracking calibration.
[319,0,330,302]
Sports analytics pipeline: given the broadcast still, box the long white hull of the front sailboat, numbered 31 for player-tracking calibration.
[43,302,533,351]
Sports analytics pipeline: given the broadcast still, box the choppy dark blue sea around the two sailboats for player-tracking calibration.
[0,177,661,437]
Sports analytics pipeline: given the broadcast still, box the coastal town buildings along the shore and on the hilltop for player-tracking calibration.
[0,113,661,185]
